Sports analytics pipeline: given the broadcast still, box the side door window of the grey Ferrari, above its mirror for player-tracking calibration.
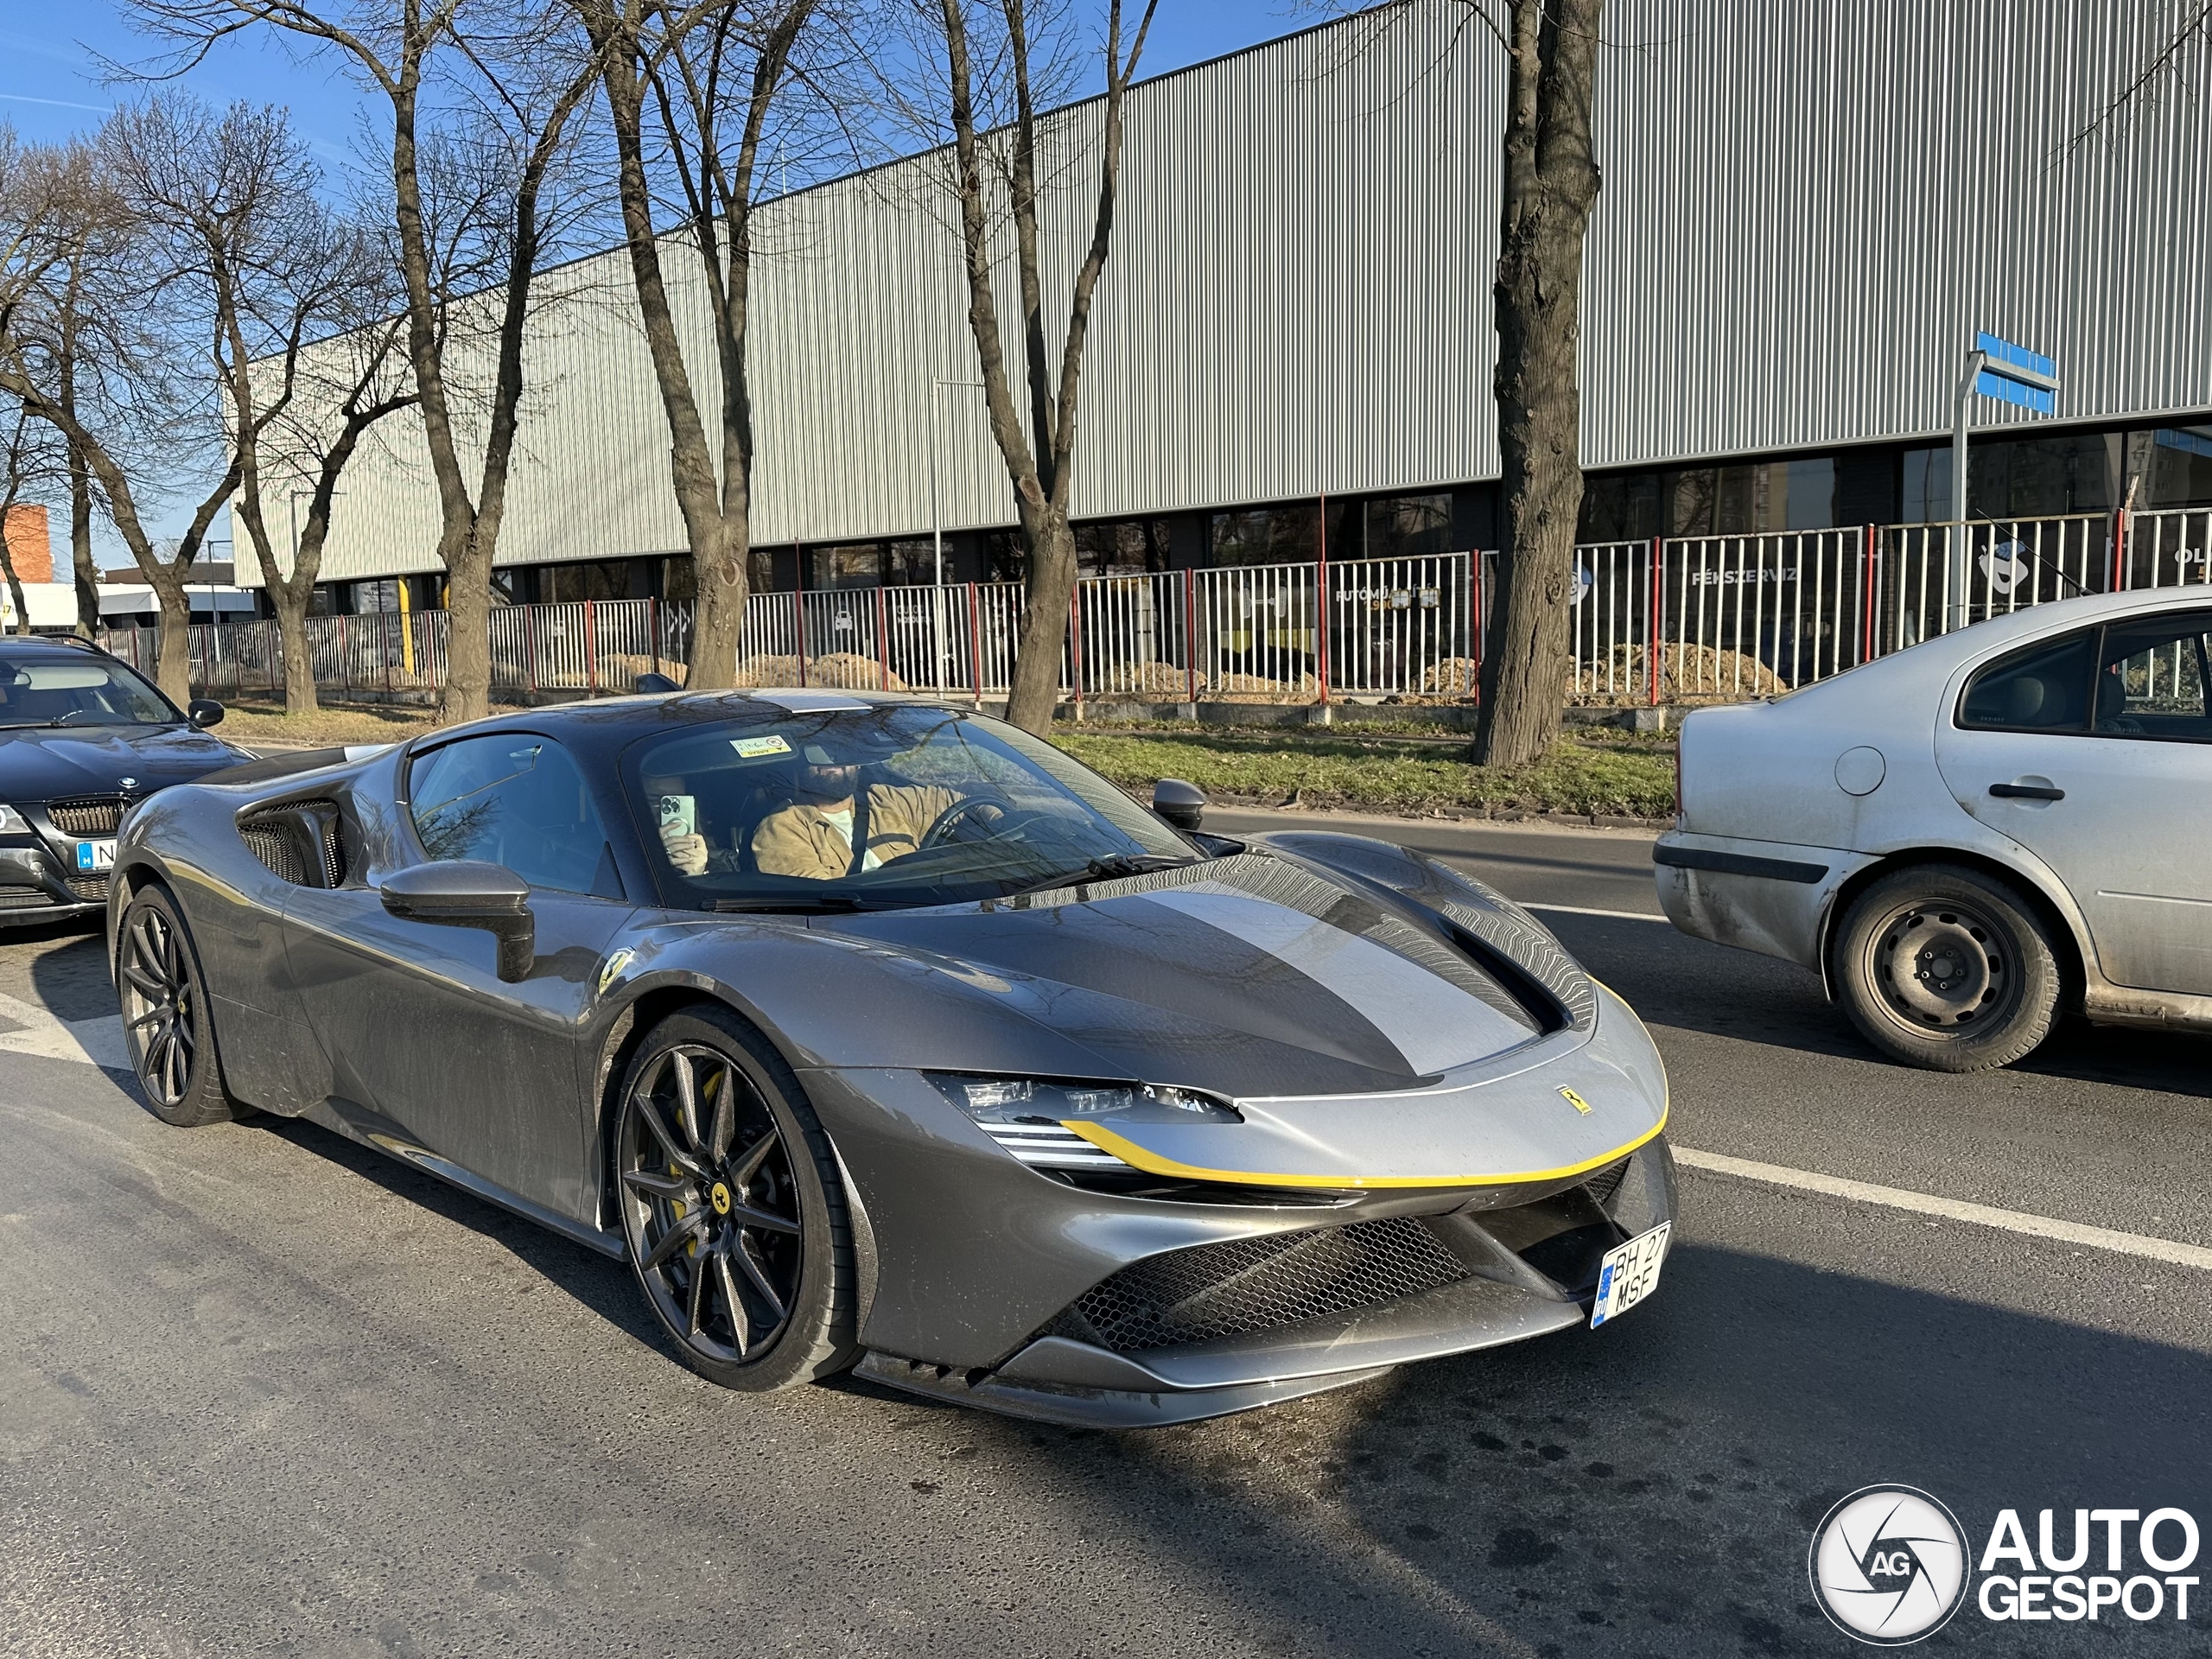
[410,732,621,898]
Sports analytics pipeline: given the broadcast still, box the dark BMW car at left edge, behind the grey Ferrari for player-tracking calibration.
[0,637,252,925]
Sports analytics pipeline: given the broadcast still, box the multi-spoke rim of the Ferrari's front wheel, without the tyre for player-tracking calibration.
[615,1044,805,1365]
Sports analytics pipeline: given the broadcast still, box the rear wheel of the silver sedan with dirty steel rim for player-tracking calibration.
[1834,865,2059,1071]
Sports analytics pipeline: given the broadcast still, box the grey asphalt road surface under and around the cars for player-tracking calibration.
[0,812,2212,1659]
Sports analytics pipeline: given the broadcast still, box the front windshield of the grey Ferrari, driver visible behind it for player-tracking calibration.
[624,703,1194,909]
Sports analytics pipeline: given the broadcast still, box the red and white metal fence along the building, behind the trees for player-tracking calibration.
[104,509,2212,703]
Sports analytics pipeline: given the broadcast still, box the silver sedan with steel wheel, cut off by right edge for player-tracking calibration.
[1652,588,2212,1071]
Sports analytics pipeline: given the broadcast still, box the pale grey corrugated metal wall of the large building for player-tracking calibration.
[276,0,2212,580]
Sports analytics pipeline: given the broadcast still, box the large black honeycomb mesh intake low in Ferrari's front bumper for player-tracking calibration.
[1053,1217,1469,1354]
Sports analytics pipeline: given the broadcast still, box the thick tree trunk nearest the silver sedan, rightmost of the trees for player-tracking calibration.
[1476,0,1601,766]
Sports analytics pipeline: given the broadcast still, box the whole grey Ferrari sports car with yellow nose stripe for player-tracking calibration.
[108,692,1675,1425]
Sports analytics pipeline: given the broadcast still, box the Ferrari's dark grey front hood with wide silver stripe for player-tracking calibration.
[818,854,1564,1097]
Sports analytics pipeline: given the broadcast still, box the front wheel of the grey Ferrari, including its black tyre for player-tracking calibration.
[613,1008,852,1389]
